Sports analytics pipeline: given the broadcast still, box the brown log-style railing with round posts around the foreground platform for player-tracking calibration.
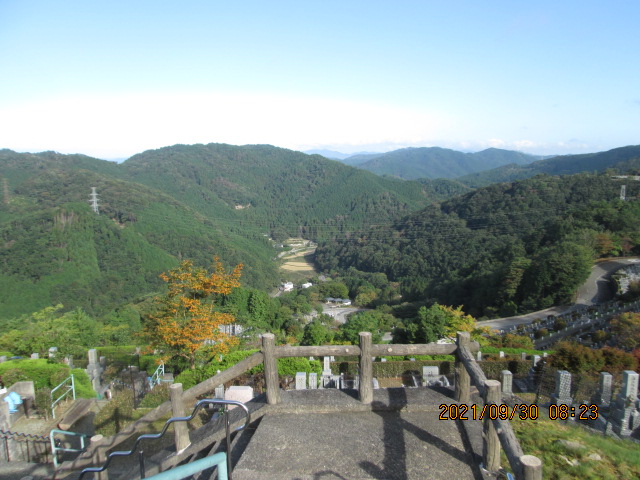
[61,332,542,480]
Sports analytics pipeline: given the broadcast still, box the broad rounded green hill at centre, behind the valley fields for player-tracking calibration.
[123,144,437,239]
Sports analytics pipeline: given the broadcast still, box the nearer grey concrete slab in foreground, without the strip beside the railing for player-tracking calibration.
[233,410,482,480]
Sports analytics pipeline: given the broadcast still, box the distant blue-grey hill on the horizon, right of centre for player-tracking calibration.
[342,147,541,180]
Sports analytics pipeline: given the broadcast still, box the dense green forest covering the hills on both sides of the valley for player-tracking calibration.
[0,144,638,332]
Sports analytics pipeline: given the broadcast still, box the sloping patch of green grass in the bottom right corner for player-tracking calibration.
[510,408,640,480]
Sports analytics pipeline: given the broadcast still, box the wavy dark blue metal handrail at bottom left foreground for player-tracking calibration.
[78,398,251,480]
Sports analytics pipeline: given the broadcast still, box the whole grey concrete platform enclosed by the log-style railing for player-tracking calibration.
[233,388,483,480]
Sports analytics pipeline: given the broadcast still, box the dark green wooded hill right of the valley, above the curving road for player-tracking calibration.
[317,174,640,317]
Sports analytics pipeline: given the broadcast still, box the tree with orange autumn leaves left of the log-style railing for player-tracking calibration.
[143,257,242,369]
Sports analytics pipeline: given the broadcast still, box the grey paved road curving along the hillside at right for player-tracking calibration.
[478,258,640,330]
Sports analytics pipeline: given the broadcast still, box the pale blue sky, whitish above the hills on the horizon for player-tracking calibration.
[0,0,640,159]
